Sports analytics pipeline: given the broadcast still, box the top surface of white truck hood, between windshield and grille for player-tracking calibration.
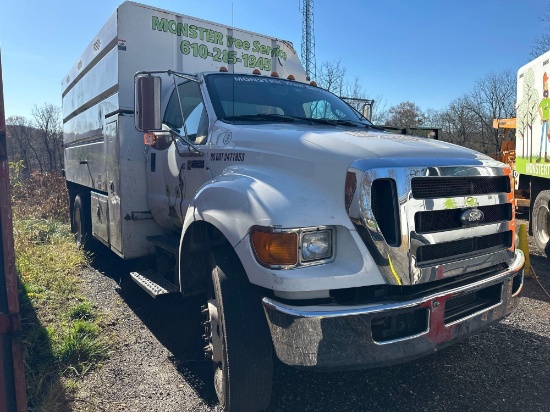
[218,123,495,168]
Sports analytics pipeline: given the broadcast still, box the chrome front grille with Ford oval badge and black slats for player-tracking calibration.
[346,161,515,285]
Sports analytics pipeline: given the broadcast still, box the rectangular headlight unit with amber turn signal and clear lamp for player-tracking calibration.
[250,226,334,269]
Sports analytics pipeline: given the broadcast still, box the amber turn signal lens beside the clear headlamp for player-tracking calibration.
[252,229,298,266]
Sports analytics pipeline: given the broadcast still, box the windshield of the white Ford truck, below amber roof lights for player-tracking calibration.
[206,74,371,126]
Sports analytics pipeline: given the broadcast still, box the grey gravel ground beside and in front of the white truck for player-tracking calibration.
[70,222,550,412]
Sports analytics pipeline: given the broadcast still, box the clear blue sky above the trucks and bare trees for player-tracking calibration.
[0,0,550,119]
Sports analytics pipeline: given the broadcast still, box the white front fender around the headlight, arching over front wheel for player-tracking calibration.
[182,166,383,296]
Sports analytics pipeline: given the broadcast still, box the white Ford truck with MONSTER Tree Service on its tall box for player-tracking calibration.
[62,2,524,412]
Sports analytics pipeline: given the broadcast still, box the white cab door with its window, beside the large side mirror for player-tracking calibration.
[148,81,209,229]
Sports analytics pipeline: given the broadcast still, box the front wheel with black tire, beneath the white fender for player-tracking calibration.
[203,244,273,412]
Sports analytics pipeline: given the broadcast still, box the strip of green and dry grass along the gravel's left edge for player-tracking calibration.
[11,173,109,411]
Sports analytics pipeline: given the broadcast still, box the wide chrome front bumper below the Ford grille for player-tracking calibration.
[263,250,525,370]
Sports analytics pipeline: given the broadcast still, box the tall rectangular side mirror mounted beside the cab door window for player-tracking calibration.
[134,74,162,132]
